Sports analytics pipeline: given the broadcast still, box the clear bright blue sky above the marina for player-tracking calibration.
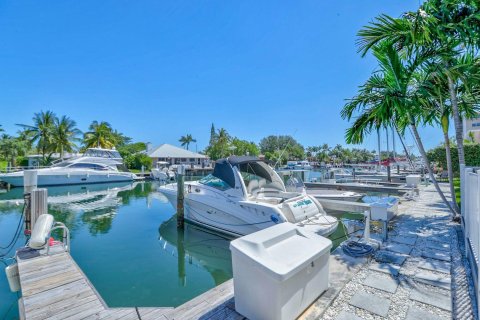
[0,0,441,154]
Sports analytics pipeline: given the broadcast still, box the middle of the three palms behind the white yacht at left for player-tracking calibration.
[52,116,81,158]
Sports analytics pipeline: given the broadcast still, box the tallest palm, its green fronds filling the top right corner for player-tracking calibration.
[359,0,480,168]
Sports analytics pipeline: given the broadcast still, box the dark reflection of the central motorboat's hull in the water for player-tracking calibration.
[159,216,232,286]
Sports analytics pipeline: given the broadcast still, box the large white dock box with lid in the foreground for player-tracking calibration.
[230,223,332,320]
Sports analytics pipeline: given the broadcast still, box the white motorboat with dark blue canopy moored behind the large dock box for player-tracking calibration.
[158,156,338,236]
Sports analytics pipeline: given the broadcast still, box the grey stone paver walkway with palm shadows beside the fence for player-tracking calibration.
[321,186,474,320]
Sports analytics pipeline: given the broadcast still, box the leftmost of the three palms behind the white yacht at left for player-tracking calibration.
[17,111,56,161]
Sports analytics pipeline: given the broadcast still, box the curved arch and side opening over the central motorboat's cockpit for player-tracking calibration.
[238,161,285,193]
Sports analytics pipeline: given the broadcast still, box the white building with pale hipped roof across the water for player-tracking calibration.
[147,143,209,167]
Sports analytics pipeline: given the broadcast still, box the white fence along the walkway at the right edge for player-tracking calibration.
[460,166,480,314]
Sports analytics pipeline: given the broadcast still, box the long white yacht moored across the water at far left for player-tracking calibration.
[0,148,136,187]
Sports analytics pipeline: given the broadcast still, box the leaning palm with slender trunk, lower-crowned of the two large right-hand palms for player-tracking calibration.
[342,41,455,214]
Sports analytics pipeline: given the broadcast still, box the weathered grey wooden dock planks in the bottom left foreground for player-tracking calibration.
[18,248,235,320]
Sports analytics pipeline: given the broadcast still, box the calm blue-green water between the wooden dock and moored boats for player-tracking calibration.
[0,182,232,319]
